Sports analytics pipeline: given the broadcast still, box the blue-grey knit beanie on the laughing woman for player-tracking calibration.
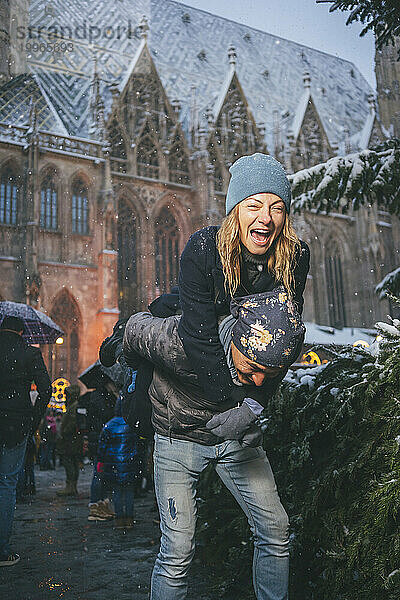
[226,152,292,214]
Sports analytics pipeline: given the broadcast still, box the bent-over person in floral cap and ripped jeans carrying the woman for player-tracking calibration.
[124,286,305,600]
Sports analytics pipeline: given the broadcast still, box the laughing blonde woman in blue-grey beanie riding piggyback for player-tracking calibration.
[178,153,310,412]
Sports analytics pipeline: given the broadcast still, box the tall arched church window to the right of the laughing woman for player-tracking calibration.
[325,246,346,329]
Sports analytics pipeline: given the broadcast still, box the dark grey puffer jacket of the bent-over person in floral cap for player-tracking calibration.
[124,312,265,445]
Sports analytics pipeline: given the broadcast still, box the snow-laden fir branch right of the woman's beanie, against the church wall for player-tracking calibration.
[289,139,400,216]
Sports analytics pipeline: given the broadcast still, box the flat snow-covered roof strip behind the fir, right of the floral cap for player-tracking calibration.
[304,322,377,346]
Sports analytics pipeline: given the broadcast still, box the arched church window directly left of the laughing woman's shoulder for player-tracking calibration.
[154,206,179,293]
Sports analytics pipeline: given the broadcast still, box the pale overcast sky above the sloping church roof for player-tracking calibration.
[176,0,376,89]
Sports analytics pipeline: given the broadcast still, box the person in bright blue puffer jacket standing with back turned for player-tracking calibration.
[97,396,139,529]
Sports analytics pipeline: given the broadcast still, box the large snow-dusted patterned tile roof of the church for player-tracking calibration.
[1,0,372,149]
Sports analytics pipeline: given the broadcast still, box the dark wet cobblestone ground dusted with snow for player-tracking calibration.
[0,465,217,600]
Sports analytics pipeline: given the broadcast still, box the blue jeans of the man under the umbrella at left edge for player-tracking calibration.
[0,438,28,558]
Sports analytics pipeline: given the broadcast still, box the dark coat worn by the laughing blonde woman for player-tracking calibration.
[178,226,310,402]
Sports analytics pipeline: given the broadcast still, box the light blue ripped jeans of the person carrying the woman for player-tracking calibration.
[151,434,289,600]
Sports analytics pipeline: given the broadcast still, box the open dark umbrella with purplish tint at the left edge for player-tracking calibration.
[0,301,64,344]
